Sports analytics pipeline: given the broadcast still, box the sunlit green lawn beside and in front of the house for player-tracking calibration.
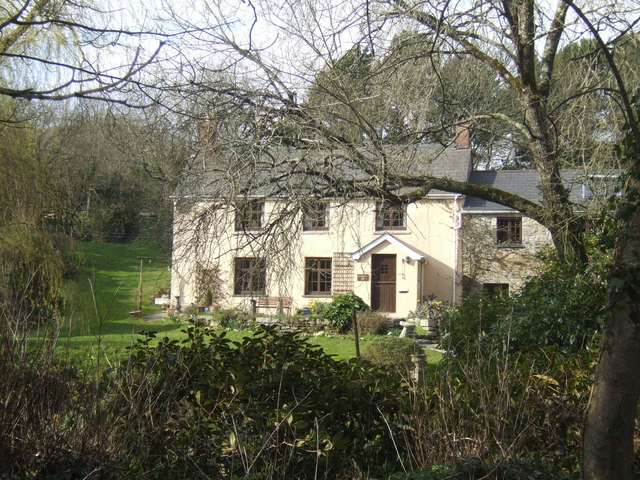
[50,242,441,364]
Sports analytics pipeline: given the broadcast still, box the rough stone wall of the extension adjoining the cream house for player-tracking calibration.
[460,212,551,294]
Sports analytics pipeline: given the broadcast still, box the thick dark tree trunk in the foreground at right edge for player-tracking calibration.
[582,172,640,480]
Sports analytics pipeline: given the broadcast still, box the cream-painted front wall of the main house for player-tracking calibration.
[171,196,462,317]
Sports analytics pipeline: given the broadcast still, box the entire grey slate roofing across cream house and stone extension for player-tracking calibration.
[175,145,617,212]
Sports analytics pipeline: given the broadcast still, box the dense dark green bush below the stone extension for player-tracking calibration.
[445,249,610,349]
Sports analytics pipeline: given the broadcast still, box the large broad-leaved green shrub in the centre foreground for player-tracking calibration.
[109,327,406,478]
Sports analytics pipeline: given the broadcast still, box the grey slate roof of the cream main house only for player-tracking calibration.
[175,145,471,198]
